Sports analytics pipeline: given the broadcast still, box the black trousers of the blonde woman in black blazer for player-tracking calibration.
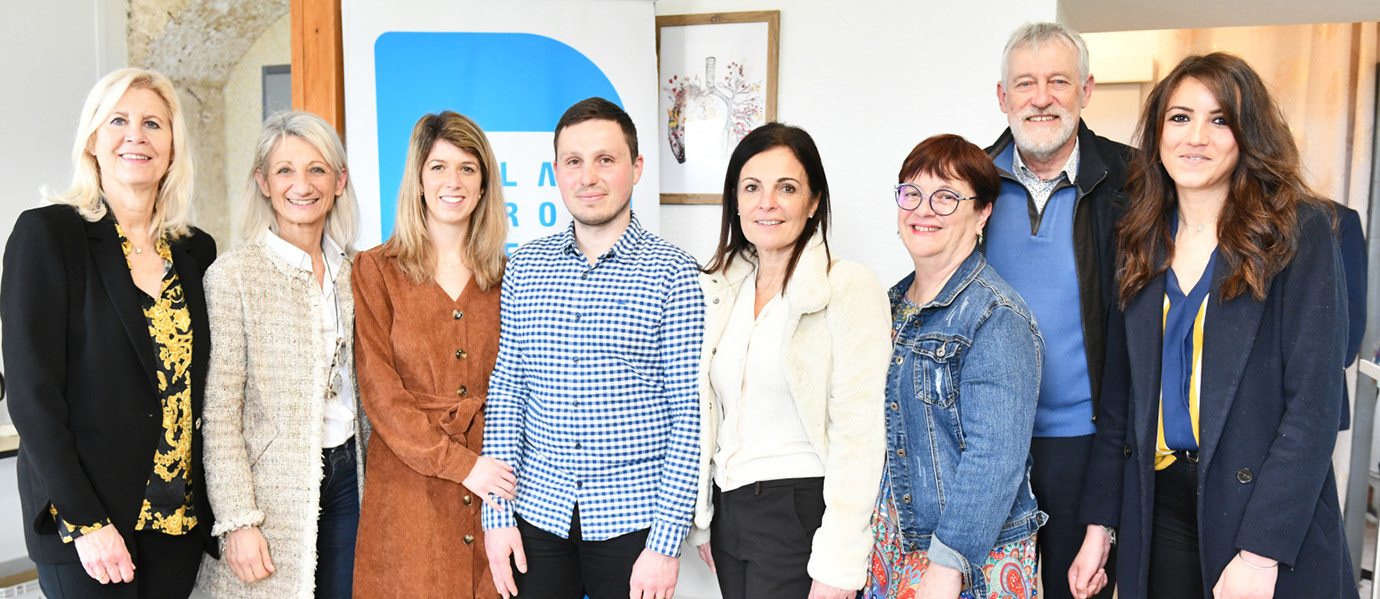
[37,529,206,599]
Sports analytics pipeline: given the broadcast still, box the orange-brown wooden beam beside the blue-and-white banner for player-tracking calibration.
[291,0,345,138]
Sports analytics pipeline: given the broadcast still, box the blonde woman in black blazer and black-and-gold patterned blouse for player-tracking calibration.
[0,69,215,599]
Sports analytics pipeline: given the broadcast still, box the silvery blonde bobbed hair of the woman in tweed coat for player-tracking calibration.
[240,110,359,253]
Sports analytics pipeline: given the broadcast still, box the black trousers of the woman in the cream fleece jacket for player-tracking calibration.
[709,478,824,599]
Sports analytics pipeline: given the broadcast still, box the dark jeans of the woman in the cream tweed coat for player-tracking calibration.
[316,439,359,599]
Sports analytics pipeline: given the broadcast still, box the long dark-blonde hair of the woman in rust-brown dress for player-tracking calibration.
[384,110,508,291]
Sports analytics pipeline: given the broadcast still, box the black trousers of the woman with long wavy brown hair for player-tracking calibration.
[1147,457,1206,599]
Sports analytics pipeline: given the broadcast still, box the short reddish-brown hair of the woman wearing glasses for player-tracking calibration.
[896,134,1002,211]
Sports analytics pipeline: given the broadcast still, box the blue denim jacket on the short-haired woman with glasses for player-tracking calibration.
[886,251,1046,596]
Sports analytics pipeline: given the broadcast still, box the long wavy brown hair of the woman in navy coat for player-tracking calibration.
[1116,52,1325,308]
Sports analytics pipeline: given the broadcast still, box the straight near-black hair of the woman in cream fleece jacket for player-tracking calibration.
[704,123,834,291]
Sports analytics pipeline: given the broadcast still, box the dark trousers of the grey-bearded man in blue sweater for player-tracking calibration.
[1031,435,1116,599]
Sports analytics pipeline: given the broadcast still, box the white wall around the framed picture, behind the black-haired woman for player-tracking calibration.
[645,0,1056,599]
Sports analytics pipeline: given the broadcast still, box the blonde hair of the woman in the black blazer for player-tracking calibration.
[43,69,195,239]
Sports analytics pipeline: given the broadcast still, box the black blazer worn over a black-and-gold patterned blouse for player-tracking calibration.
[0,206,215,563]
